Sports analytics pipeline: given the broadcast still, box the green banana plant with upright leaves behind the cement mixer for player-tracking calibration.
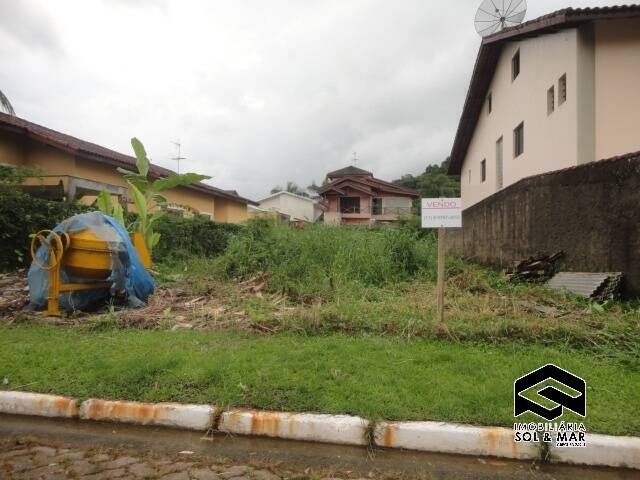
[98,137,211,252]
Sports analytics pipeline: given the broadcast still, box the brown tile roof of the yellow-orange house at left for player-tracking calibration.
[0,112,258,205]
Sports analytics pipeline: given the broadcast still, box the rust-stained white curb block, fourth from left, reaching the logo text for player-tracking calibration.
[373,422,541,460]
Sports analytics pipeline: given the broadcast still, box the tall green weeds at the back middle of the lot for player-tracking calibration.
[216,220,436,302]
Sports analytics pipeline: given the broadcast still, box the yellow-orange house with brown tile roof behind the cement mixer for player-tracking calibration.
[0,112,258,223]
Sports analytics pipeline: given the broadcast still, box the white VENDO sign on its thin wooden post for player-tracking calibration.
[422,198,462,324]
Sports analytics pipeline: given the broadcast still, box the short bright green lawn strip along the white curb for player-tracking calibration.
[0,325,640,435]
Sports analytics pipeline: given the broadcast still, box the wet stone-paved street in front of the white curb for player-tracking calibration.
[0,414,638,480]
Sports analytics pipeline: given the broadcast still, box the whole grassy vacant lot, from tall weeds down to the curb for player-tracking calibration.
[0,222,640,435]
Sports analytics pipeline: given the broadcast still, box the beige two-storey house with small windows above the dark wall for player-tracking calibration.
[449,6,640,208]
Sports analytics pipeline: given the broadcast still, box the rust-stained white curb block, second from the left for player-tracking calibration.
[80,399,219,431]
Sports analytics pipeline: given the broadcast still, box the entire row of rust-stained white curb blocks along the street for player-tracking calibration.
[0,391,640,470]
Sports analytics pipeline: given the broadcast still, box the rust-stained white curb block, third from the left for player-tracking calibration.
[218,409,369,445]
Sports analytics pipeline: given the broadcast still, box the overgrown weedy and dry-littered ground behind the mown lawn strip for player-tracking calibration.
[0,222,640,353]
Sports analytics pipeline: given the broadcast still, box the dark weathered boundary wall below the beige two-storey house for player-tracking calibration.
[447,152,640,297]
